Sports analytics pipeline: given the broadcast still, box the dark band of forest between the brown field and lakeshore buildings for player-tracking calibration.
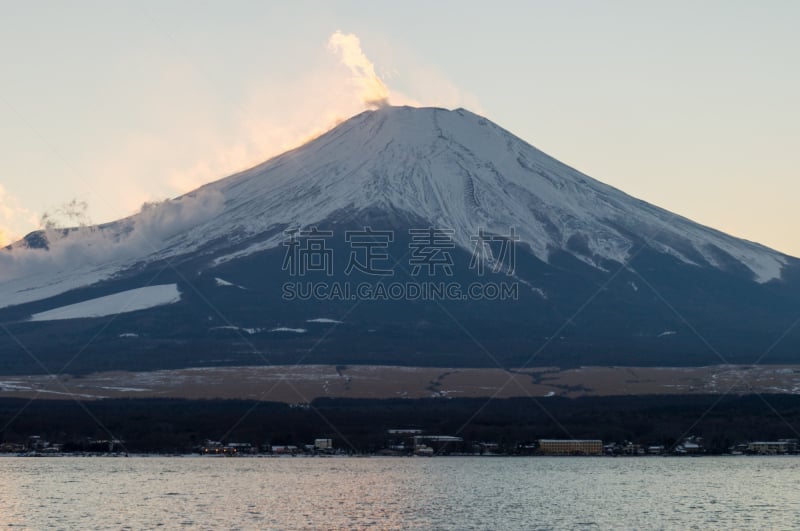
[0,395,800,453]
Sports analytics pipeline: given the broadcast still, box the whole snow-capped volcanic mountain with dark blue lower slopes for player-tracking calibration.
[0,107,800,374]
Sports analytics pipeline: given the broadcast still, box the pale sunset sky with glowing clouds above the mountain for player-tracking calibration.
[0,0,800,256]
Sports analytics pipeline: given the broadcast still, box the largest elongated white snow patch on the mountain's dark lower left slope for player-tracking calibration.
[30,284,181,321]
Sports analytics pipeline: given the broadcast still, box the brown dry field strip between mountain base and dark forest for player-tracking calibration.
[0,365,800,404]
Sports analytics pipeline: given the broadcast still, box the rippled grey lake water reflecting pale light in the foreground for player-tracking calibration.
[0,457,800,530]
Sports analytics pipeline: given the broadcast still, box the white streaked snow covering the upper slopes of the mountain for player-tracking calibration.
[0,107,788,307]
